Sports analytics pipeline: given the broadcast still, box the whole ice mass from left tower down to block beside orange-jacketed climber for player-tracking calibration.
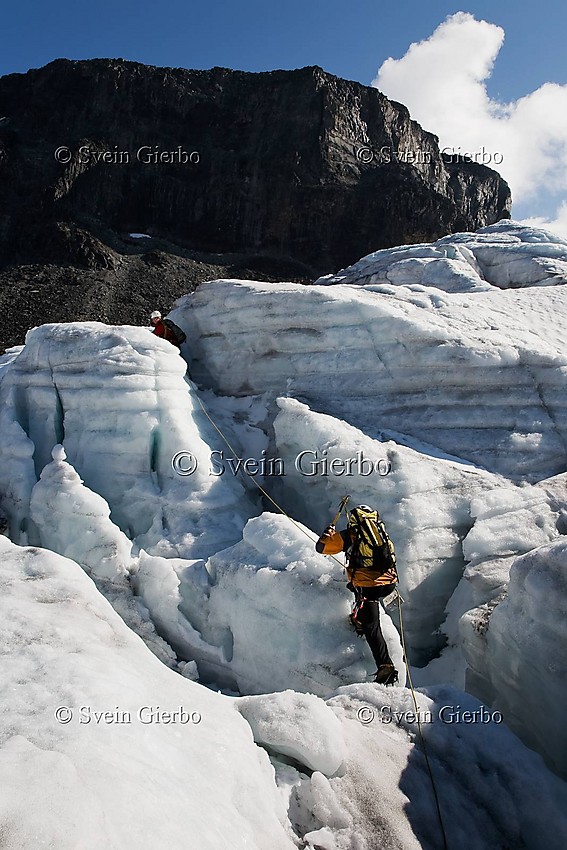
[0,324,404,693]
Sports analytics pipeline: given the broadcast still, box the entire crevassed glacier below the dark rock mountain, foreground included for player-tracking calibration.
[0,222,567,850]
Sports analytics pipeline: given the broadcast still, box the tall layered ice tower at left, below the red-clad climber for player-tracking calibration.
[0,322,256,557]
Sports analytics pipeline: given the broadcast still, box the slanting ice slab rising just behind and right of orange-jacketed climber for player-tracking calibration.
[270,398,559,664]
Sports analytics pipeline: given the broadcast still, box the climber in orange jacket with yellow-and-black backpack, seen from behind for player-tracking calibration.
[315,505,398,685]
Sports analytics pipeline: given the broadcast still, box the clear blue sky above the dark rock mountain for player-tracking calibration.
[0,0,567,232]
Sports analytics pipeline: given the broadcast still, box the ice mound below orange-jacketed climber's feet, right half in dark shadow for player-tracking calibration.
[322,684,567,850]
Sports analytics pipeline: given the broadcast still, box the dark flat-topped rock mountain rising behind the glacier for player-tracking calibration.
[0,60,510,348]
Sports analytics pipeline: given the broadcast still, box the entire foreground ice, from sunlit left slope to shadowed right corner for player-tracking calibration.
[0,538,567,850]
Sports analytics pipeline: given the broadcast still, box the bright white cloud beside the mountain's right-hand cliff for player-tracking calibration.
[372,12,567,236]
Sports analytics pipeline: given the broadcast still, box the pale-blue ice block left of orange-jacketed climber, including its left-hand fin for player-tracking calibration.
[136,513,405,695]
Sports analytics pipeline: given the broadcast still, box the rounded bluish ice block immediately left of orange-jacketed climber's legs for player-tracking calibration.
[185,513,404,695]
